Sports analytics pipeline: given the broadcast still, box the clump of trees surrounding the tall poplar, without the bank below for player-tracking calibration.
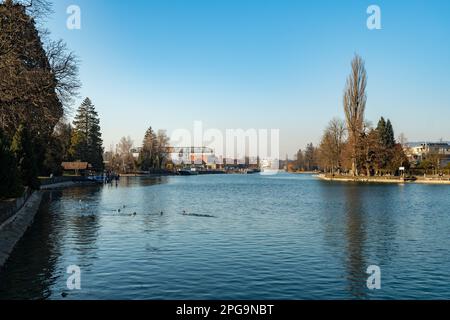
[294,55,410,176]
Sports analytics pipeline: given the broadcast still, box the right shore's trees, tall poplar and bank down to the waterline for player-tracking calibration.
[286,54,450,184]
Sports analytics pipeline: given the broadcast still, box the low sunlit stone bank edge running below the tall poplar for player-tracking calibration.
[316,174,450,185]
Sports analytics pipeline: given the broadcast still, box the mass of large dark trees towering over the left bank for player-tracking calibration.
[0,0,81,198]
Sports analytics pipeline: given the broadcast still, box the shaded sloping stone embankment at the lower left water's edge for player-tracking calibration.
[0,191,42,270]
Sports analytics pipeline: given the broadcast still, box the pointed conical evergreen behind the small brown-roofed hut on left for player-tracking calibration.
[70,98,103,170]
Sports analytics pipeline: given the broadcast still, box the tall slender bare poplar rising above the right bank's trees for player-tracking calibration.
[344,55,367,175]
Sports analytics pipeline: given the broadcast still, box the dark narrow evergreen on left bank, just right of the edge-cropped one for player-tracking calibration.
[11,124,39,189]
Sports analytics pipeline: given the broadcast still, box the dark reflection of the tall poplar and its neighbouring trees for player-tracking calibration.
[321,183,400,299]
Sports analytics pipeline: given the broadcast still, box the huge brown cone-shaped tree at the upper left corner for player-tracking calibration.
[0,0,63,136]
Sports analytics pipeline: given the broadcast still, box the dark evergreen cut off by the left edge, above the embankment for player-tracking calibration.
[0,129,23,199]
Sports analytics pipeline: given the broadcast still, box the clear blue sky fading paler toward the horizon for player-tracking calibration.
[44,0,450,156]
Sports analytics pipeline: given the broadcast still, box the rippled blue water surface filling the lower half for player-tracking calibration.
[0,174,450,299]
